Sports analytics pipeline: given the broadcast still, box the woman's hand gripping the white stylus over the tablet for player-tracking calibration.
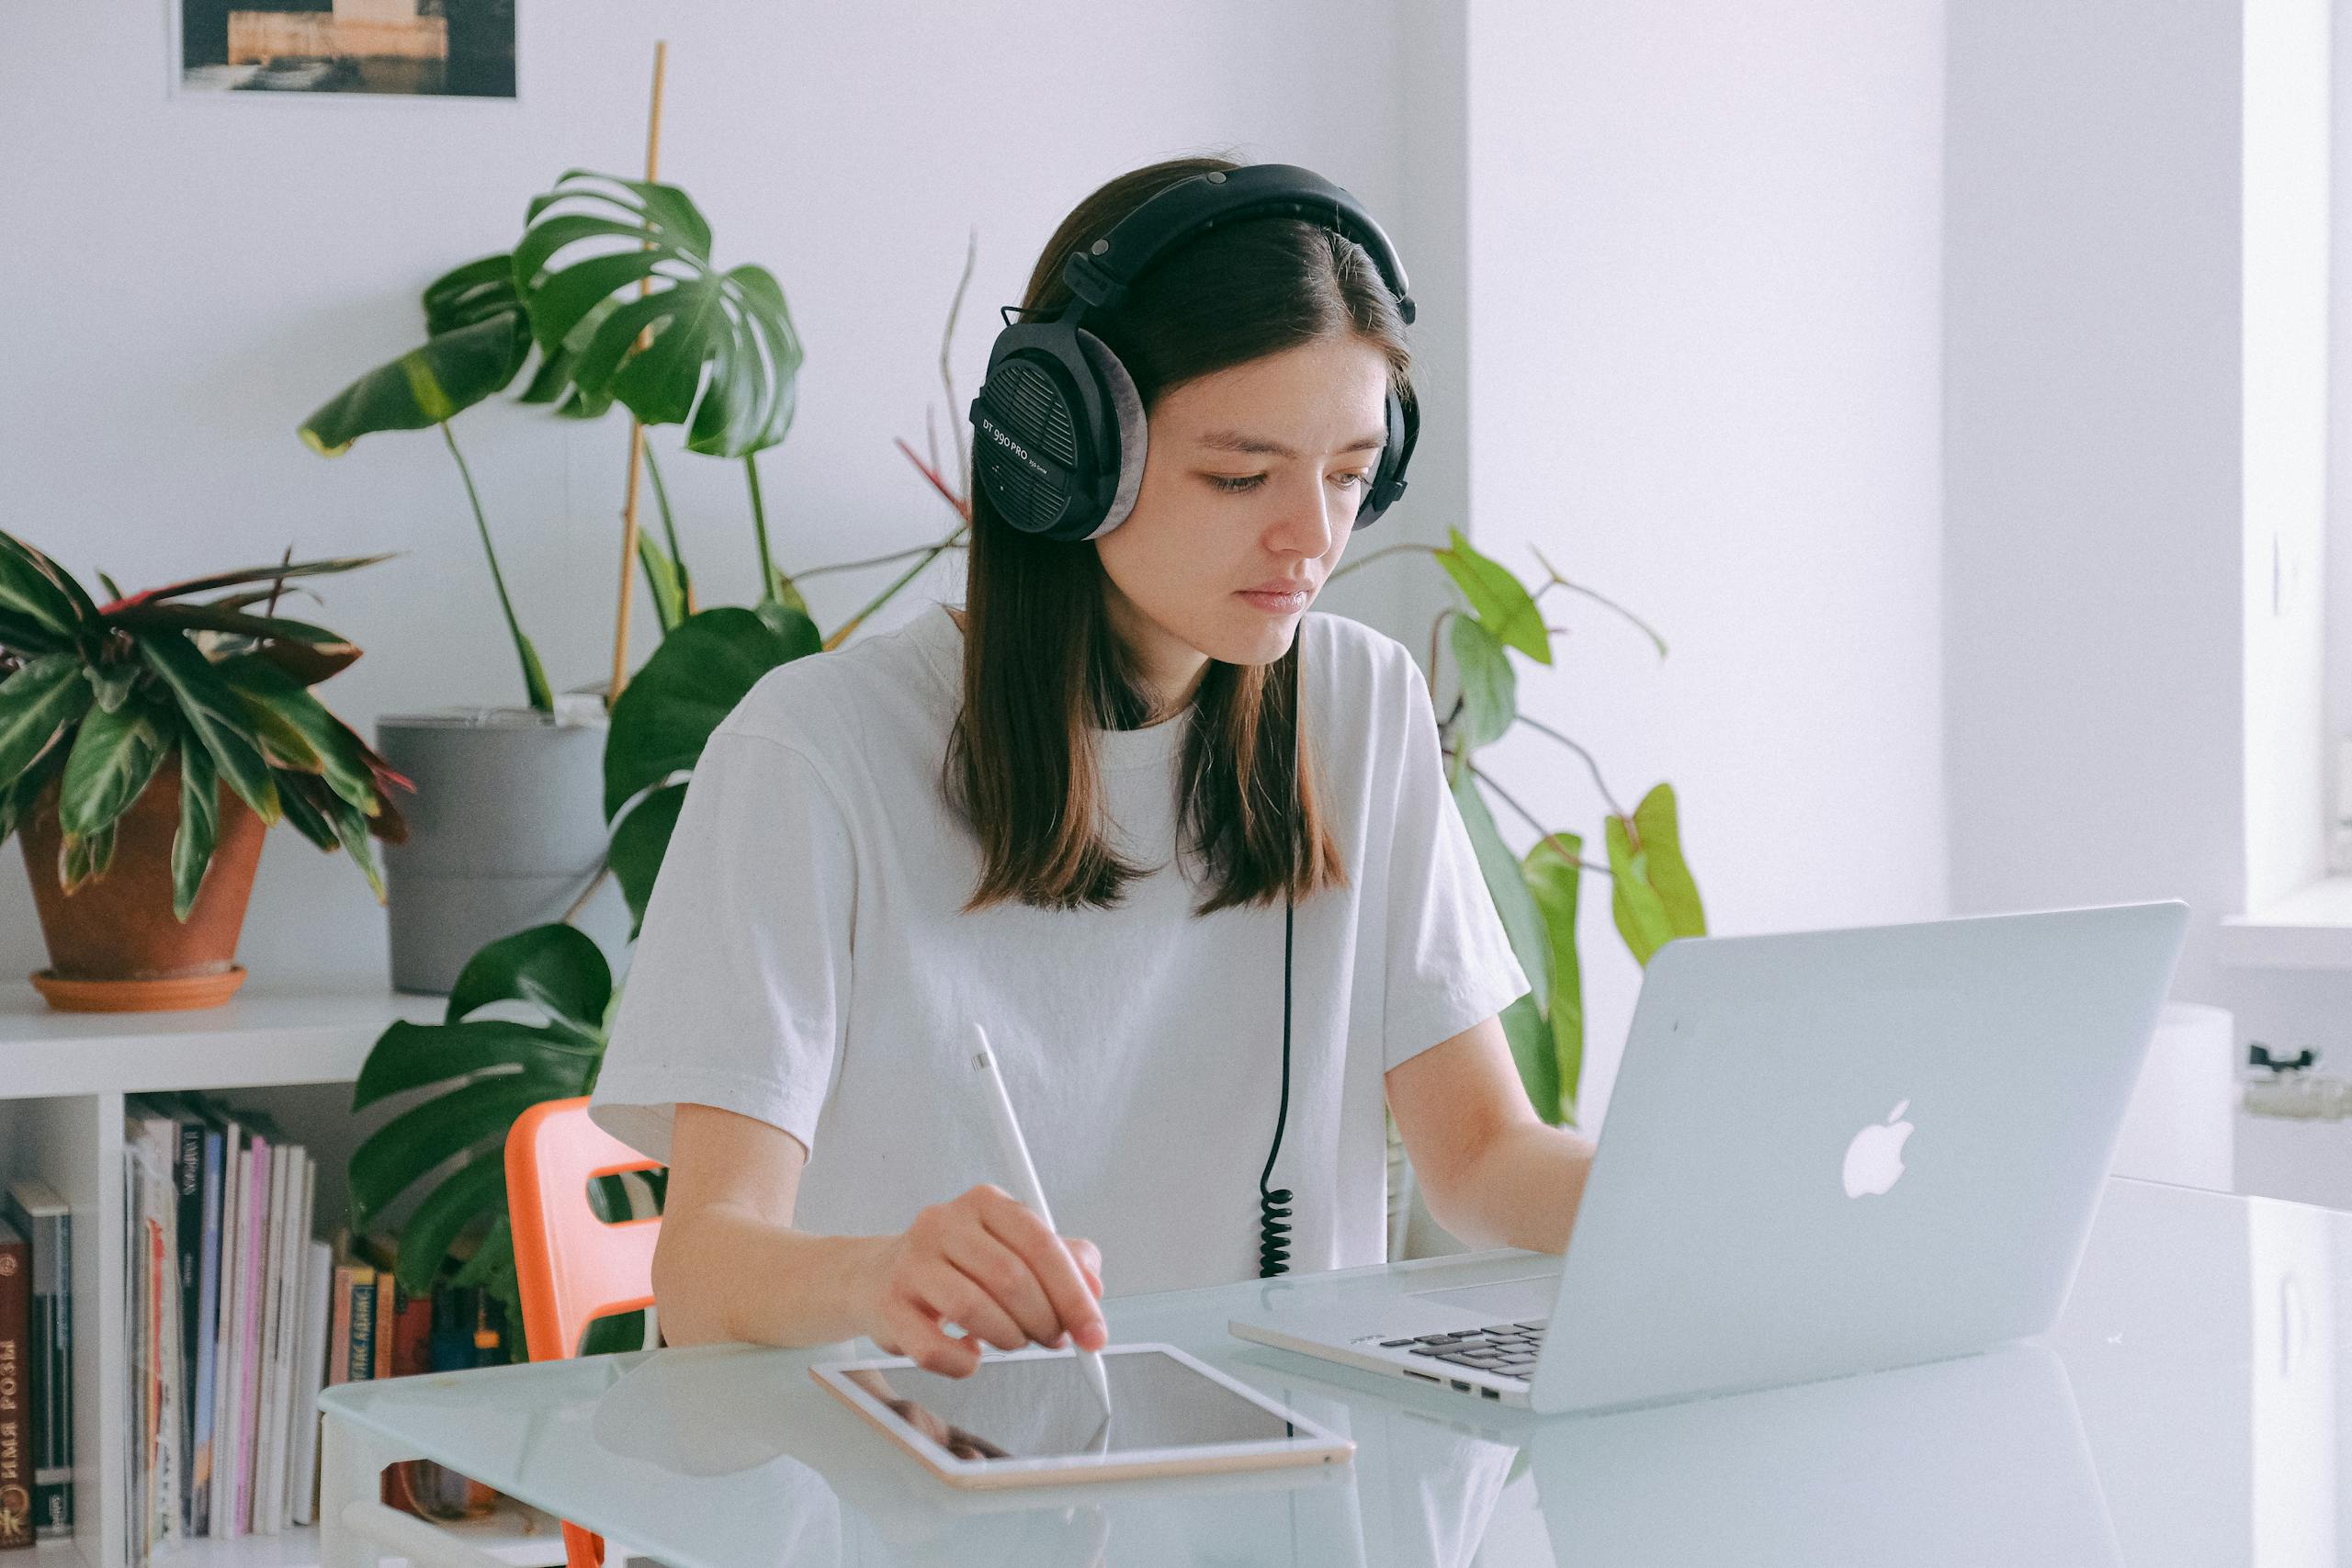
[852,1185,1110,1378]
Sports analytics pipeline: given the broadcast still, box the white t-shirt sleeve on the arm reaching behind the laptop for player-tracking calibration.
[1381,651,1532,1069]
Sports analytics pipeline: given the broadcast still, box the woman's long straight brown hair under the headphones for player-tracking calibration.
[944,157,1411,915]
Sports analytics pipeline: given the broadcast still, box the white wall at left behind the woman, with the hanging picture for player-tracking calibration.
[0,0,1465,985]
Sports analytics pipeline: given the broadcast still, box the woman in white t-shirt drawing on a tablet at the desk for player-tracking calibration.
[593,157,1590,1375]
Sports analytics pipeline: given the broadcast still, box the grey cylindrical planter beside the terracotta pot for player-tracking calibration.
[377,698,628,995]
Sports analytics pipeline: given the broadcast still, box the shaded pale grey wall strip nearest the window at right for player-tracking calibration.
[1943,0,2246,1004]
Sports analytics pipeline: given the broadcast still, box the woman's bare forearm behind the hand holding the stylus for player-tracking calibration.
[654,1203,891,1345]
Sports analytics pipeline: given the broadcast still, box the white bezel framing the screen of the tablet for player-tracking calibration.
[809,1340,1355,1488]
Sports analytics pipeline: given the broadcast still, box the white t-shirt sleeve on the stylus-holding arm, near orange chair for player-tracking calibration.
[588,728,856,1161]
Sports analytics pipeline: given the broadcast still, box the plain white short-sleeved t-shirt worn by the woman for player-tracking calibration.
[591,604,1529,1295]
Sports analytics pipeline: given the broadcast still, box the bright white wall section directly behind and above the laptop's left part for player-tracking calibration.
[1470,0,1945,1126]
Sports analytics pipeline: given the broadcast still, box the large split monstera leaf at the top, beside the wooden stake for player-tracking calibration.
[513,169,802,458]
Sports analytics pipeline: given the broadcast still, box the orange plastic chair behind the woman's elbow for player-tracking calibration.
[505,1098,661,1568]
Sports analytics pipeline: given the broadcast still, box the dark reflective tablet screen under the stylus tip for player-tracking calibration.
[842,1349,1296,1460]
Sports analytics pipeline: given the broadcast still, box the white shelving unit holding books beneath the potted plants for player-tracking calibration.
[0,980,562,1568]
